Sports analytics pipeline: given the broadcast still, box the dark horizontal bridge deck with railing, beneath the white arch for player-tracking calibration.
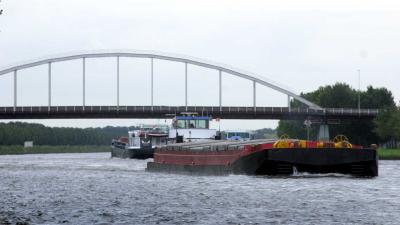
[0,106,378,120]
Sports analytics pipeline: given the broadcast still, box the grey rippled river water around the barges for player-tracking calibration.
[0,153,400,224]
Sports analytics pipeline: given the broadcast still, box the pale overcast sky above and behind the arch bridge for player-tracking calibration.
[0,0,400,130]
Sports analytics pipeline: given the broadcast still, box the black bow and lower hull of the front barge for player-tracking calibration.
[147,148,378,177]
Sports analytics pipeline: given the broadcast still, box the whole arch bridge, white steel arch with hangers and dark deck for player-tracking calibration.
[0,50,375,119]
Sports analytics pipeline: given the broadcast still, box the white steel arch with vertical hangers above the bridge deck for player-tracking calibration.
[0,50,322,109]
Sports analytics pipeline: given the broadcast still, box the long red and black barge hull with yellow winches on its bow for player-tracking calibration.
[147,135,378,177]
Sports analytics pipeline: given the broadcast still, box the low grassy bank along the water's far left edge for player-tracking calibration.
[0,145,111,155]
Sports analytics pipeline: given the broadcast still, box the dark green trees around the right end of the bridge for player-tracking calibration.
[277,83,400,146]
